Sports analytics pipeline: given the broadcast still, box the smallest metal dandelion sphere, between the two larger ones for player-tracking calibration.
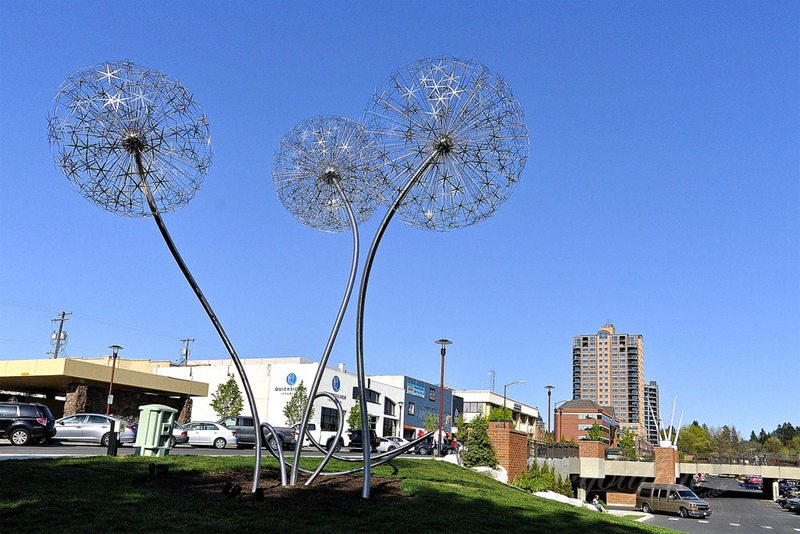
[272,115,385,232]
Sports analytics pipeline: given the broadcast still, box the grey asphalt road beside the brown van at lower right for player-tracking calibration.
[646,477,800,534]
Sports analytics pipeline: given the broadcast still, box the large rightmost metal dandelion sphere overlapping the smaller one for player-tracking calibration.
[365,57,530,231]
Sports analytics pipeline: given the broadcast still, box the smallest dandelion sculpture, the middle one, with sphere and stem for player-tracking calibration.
[272,115,386,490]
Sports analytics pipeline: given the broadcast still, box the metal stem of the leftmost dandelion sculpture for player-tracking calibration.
[134,152,262,494]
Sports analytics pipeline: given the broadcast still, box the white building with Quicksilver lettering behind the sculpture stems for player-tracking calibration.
[153,358,405,439]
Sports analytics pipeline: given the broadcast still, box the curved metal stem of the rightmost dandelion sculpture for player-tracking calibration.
[356,150,439,499]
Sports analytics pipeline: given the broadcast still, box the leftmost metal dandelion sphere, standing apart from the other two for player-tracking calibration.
[48,61,211,217]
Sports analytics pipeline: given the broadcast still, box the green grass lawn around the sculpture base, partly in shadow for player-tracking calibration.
[0,456,673,534]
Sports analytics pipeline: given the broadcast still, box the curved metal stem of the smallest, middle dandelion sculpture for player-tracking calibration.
[290,179,358,485]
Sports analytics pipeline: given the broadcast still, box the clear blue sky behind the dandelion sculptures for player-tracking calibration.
[0,1,800,437]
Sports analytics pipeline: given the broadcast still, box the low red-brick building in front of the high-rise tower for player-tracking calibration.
[554,399,619,447]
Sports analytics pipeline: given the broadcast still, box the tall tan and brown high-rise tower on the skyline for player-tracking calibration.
[572,324,647,439]
